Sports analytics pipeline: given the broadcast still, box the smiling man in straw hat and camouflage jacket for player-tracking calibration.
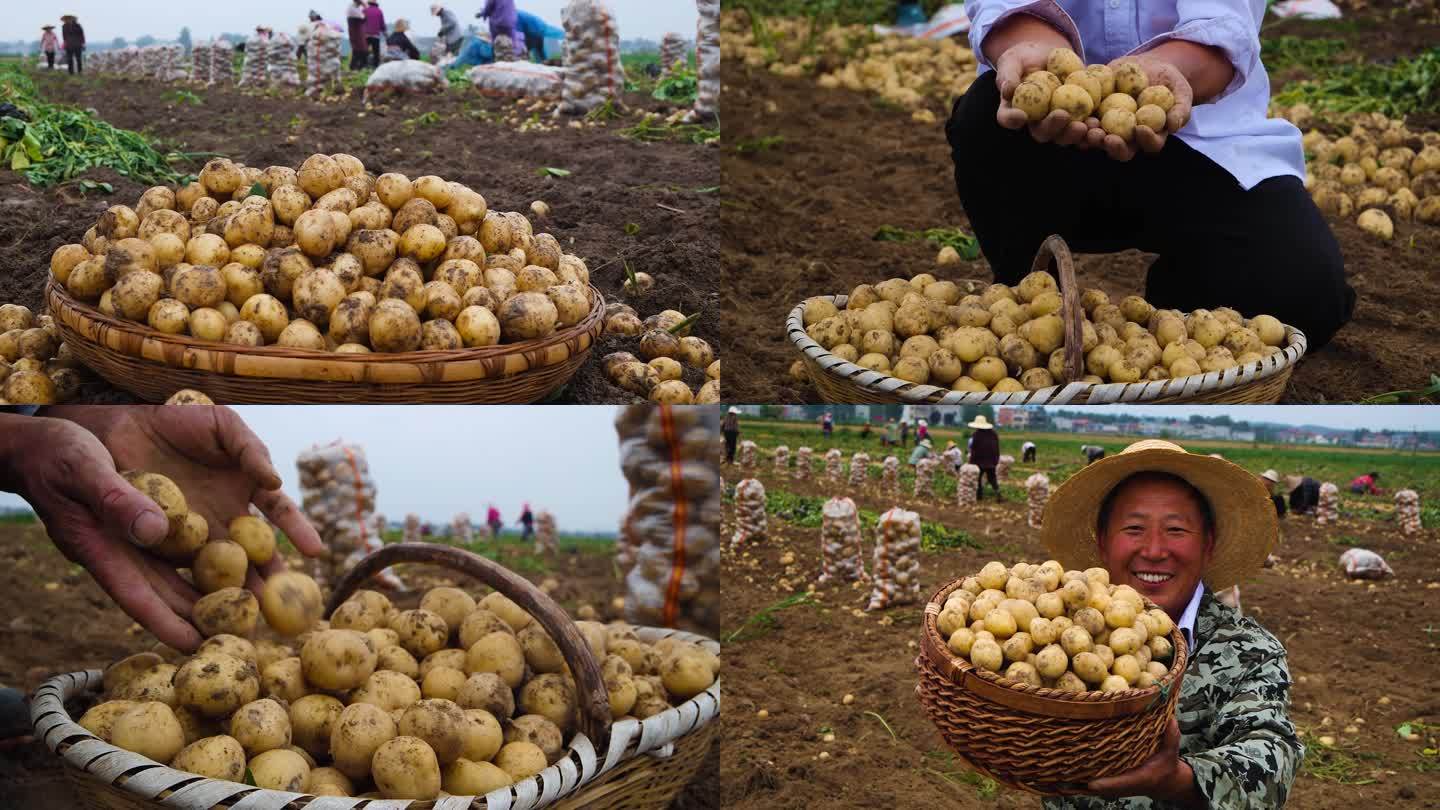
[1043,441,1305,810]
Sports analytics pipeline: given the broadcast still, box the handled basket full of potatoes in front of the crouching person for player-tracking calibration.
[785,236,1306,405]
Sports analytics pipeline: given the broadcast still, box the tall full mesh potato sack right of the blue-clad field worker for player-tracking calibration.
[560,0,625,115]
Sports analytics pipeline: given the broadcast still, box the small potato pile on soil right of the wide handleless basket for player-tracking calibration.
[602,303,720,405]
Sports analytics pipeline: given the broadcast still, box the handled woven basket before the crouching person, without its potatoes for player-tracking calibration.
[785,236,1308,405]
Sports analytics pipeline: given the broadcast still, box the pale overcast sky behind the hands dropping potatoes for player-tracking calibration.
[0,405,629,532]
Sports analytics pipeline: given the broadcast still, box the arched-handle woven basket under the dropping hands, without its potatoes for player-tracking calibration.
[30,543,720,810]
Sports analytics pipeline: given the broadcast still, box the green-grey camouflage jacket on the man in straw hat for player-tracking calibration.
[1044,591,1305,810]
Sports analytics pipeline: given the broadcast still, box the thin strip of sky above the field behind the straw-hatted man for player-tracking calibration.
[1031,405,1440,431]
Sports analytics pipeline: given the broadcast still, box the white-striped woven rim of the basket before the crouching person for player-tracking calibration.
[785,294,1309,405]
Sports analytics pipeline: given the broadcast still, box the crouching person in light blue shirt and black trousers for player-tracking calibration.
[946,0,1355,347]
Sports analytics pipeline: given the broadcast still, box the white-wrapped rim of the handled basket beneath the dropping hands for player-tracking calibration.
[30,626,720,807]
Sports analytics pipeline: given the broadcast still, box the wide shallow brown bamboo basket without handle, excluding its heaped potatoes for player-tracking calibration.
[46,280,605,405]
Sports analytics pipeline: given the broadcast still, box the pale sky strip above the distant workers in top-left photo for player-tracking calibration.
[9,0,698,43]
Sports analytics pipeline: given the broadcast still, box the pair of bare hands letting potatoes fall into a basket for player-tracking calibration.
[0,405,324,653]
